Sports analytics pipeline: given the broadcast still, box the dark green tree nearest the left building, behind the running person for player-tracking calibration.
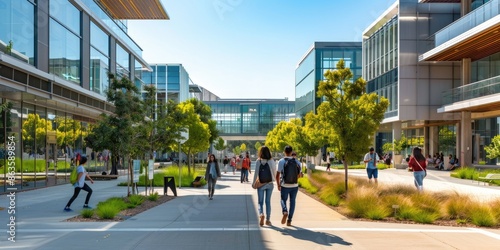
[87,74,145,179]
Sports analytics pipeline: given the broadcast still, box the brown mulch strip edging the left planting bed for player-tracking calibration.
[66,195,175,222]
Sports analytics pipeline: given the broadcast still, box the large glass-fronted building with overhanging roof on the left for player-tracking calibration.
[0,0,168,192]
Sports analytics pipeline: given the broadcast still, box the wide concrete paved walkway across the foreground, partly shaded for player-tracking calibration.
[0,169,500,250]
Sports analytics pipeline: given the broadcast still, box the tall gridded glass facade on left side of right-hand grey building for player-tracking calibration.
[363,17,399,118]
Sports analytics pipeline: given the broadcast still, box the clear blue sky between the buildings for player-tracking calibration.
[129,0,394,100]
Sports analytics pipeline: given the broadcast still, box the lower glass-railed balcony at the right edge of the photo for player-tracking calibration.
[442,73,500,111]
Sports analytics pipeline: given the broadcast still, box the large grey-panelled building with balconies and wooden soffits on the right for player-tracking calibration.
[363,0,500,166]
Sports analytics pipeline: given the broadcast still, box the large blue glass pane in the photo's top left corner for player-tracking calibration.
[0,0,35,65]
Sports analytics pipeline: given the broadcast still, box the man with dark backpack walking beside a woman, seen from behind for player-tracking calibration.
[276,145,302,226]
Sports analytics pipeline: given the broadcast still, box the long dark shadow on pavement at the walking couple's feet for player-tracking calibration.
[270,226,352,246]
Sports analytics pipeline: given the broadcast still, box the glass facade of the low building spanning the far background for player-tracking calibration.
[205,101,295,136]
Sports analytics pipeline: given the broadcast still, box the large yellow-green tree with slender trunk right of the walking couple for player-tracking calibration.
[317,60,389,190]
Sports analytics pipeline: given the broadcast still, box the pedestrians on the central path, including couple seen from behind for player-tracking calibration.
[205,146,302,226]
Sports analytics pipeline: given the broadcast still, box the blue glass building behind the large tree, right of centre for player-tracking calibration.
[295,42,362,117]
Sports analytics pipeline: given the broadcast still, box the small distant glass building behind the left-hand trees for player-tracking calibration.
[142,64,190,103]
